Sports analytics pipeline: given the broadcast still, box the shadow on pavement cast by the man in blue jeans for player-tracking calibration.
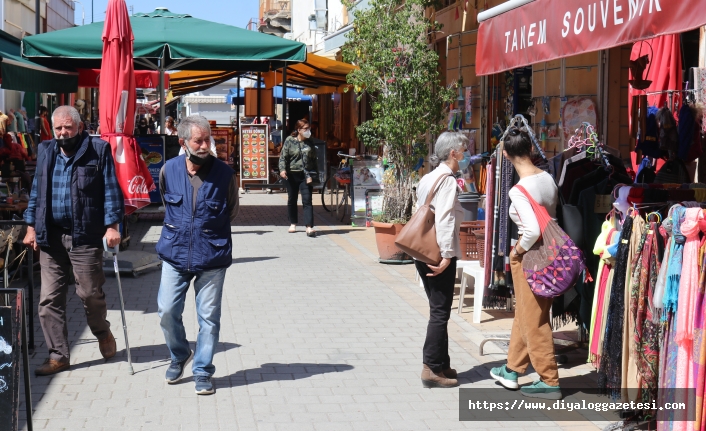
[209,363,353,388]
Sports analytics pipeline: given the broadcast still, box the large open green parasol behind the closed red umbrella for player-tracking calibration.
[22,8,306,126]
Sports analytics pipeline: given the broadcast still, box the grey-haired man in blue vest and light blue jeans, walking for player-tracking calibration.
[157,115,238,395]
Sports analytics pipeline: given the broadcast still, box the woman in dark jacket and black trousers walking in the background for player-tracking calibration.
[279,119,318,237]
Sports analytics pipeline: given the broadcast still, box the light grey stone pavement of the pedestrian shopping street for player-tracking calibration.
[15,192,605,431]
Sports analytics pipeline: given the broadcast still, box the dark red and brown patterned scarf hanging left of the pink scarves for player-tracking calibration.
[630,223,660,403]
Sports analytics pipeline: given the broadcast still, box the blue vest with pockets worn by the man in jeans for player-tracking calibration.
[157,155,233,272]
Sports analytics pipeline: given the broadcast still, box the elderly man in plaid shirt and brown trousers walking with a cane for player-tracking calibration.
[24,106,124,376]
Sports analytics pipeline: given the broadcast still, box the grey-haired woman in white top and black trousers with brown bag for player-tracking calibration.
[415,132,470,388]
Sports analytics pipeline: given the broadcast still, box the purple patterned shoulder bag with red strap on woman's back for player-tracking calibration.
[508,185,590,298]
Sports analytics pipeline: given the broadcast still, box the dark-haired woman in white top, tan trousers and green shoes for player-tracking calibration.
[490,127,561,399]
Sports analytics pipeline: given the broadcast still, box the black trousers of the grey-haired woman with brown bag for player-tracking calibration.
[414,257,456,373]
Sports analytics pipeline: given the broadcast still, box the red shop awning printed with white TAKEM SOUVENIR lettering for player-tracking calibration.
[476,0,706,76]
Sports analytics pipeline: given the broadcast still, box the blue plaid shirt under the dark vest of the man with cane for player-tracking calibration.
[24,142,123,229]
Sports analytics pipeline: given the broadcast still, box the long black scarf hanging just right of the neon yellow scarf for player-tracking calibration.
[598,217,633,398]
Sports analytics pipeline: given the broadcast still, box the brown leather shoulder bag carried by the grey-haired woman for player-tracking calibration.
[395,175,453,265]
